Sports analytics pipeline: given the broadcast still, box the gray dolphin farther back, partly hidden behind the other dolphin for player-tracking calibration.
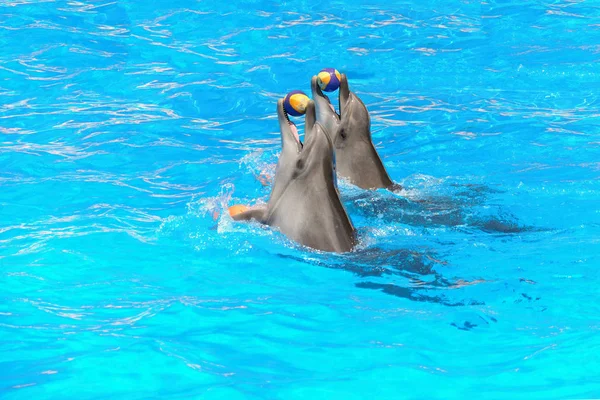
[311,74,401,190]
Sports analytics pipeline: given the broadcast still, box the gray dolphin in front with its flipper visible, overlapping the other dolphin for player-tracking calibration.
[233,100,356,253]
